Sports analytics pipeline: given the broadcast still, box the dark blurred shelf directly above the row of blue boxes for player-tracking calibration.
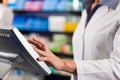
[13,10,81,17]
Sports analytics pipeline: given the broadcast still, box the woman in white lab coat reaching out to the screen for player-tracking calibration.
[28,0,120,80]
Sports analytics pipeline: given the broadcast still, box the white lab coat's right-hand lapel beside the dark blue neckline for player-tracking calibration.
[85,6,108,31]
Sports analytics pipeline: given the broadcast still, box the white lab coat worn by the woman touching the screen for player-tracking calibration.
[72,0,120,80]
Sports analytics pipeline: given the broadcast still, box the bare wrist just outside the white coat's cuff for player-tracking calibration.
[62,60,77,74]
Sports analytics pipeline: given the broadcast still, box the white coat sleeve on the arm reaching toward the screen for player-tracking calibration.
[75,20,120,80]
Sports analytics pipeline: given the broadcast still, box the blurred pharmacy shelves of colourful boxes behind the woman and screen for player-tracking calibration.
[3,0,83,80]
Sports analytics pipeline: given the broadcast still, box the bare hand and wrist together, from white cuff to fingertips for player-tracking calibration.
[28,37,76,74]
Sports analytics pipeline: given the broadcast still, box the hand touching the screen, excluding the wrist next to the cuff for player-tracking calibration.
[28,37,64,70]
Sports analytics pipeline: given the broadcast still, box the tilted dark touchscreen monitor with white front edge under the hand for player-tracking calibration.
[0,26,51,75]
